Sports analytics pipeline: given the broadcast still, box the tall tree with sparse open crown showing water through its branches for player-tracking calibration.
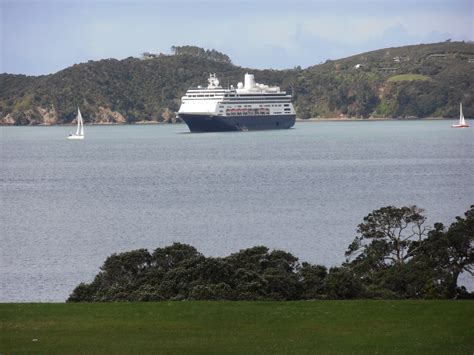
[344,206,427,298]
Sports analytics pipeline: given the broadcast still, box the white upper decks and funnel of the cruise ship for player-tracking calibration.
[178,74,295,117]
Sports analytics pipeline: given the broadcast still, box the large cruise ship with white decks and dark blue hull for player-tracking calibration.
[178,74,296,132]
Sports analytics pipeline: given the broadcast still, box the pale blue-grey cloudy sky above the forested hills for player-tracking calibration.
[0,0,474,75]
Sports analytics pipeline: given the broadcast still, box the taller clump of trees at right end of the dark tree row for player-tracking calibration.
[344,206,474,298]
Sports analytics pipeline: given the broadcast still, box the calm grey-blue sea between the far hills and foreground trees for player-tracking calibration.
[0,121,474,301]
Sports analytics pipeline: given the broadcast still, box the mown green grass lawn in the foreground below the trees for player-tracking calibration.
[0,301,474,354]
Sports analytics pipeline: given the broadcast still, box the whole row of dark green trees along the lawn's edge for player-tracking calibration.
[68,206,474,302]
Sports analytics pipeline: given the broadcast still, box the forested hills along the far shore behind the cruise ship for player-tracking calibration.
[0,42,474,125]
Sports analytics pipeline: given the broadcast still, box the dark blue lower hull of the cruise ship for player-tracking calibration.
[179,113,296,132]
